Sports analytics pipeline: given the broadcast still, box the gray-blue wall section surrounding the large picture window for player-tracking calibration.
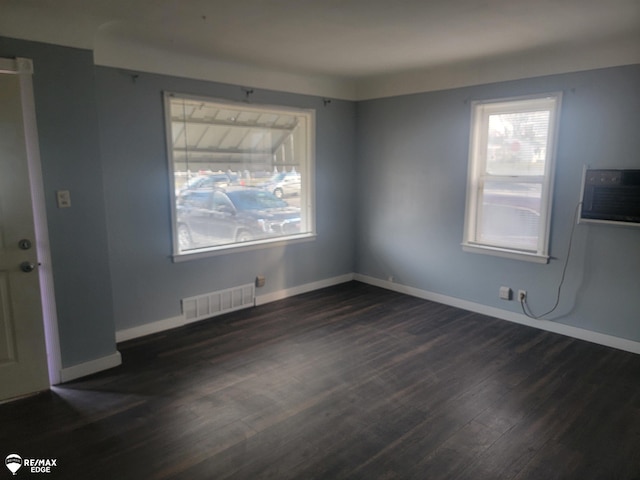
[96,68,355,329]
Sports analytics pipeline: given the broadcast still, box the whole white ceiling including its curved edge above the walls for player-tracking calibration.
[0,0,640,99]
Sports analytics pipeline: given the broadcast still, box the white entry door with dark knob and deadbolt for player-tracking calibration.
[0,59,49,400]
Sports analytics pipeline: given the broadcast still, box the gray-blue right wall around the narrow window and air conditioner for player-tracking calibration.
[356,65,640,341]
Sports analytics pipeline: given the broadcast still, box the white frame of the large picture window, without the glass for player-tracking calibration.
[164,92,316,262]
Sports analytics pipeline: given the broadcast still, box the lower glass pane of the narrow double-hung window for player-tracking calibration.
[477,181,542,251]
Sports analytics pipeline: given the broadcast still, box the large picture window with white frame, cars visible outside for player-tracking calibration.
[165,93,314,256]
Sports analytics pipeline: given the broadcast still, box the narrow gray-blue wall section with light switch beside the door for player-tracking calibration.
[0,37,115,367]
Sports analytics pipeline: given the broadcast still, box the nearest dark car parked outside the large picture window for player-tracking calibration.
[176,187,300,251]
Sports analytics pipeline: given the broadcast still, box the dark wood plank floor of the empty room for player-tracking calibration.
[0,282,640,480]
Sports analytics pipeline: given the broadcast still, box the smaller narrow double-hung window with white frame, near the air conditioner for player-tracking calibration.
[463,94,560,262]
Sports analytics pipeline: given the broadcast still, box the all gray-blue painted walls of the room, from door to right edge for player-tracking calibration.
[0,34,640,367]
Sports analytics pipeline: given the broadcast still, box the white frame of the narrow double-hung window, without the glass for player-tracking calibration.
[462,92,562,263]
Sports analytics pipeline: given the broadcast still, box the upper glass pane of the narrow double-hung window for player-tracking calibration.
[486,110,550,175]
